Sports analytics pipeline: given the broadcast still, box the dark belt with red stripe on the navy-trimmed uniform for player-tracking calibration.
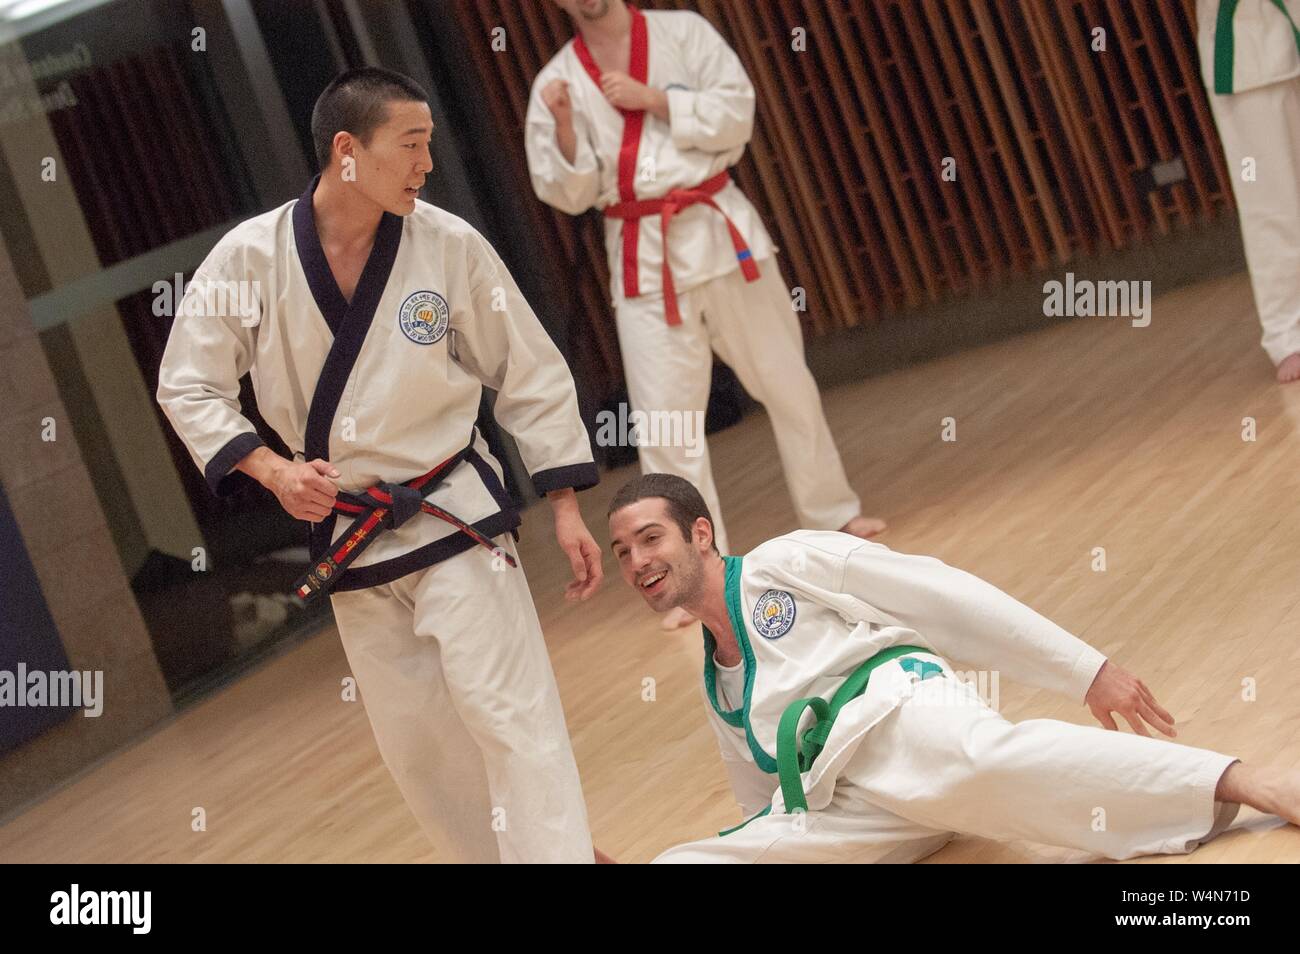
[294,447,516,600]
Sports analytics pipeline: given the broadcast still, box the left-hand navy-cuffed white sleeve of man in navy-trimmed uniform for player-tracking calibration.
[156,243,263,495]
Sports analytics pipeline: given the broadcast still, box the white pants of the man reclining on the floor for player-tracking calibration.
[655,677,1239,863]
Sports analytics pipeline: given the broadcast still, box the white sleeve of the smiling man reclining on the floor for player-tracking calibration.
[840,542,1106,702]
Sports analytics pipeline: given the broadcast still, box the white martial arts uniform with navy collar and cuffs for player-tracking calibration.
[157,177,597,862]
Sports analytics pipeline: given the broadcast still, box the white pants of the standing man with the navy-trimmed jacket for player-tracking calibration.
[330,534,593,863]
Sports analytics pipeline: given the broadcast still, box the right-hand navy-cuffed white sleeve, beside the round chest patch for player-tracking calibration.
[451,231,599,494]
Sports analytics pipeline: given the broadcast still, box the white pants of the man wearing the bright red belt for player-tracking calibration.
[615,257,862,554]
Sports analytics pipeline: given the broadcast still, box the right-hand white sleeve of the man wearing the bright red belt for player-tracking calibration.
[667,14,754,152]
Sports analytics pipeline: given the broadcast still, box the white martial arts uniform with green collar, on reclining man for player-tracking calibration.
[657,530,1238,862]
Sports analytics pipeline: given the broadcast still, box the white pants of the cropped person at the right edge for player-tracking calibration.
[1209,77,1300,364]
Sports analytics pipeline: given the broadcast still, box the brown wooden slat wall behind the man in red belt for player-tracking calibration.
[450,0,1232,400]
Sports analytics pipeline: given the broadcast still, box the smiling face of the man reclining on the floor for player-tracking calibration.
[610,496,714,612]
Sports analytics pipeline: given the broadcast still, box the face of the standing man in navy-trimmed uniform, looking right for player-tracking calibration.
[334,100,433,216]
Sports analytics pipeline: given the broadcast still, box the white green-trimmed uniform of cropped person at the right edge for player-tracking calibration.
[1196,0,1300,364]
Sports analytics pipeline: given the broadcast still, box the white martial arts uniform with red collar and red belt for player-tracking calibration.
[525,10,861,552]
